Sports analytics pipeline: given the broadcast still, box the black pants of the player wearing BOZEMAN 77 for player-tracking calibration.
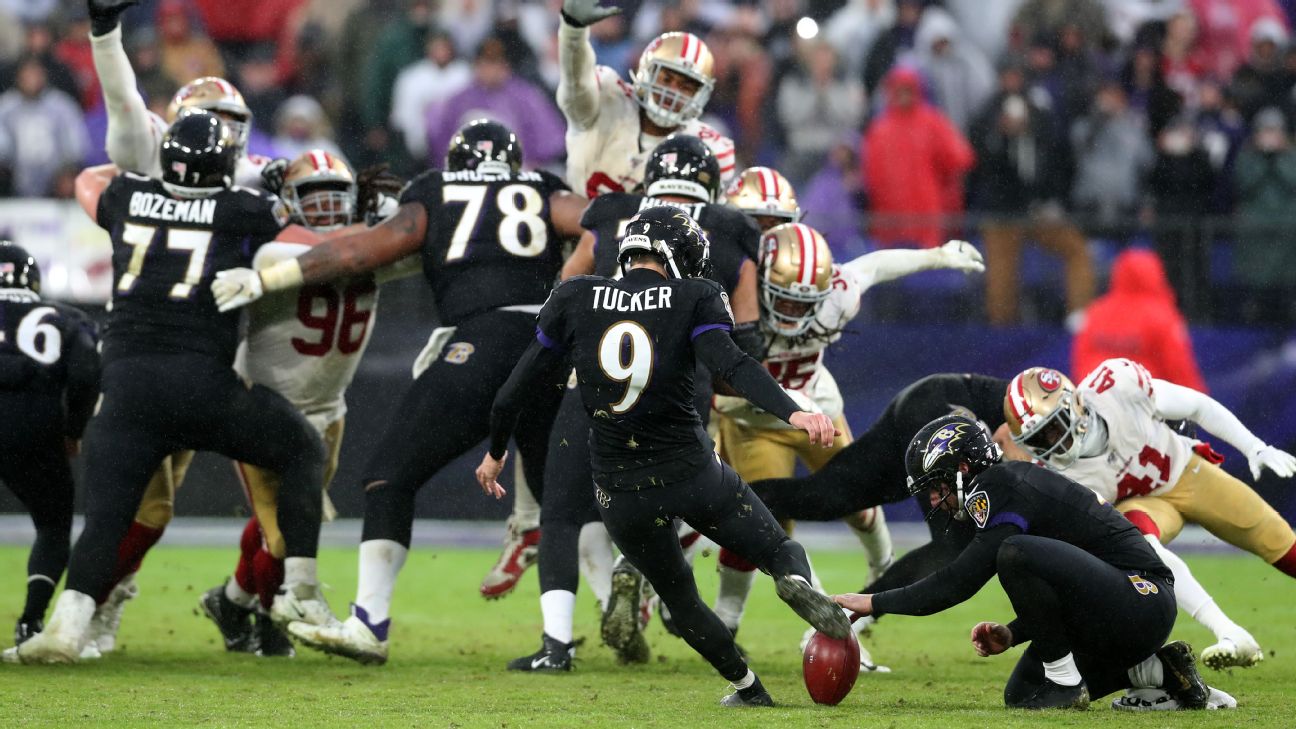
[67,354,324,595]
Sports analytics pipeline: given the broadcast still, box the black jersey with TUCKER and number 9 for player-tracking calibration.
[538,270,734,490]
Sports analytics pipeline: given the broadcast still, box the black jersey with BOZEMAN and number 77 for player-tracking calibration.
[97,173,288,363]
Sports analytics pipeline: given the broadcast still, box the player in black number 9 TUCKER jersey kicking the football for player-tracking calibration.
[477,206,850,706]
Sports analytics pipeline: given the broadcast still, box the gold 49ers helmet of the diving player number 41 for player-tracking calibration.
[1003,367,1089,468]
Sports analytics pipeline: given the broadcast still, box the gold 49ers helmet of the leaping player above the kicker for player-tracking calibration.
[630,32,715,127]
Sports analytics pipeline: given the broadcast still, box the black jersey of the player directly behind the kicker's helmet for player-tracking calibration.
[581,192,761,293]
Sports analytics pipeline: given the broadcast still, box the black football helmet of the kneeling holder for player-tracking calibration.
[905,415,1003,519]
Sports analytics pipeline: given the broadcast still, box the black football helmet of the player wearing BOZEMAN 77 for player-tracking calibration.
[161,109,238,197]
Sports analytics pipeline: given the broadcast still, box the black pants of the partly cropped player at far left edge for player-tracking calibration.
[0,390,75,621]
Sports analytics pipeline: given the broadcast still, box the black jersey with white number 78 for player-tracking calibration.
[400,170,568,326]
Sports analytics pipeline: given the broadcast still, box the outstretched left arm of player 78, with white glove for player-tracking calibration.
[211,202,428,311]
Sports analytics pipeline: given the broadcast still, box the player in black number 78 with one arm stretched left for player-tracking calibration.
[213,119,586,663]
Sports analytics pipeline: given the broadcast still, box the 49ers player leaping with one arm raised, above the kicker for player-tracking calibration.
[557,0,735,198]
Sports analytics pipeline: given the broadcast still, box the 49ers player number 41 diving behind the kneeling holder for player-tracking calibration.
[1003,359,1296,668]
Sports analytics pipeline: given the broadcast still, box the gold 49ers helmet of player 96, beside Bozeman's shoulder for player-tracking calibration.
[280,149,356,231]
